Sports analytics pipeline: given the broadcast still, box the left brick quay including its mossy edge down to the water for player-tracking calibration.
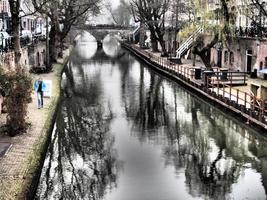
[0,48,71,199]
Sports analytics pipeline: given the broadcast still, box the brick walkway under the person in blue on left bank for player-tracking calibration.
[0,51,69,199]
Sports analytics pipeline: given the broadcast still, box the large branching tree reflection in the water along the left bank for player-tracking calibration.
[38,52,119,199]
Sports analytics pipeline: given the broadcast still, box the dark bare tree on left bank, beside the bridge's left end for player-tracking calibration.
[32,0,101,68]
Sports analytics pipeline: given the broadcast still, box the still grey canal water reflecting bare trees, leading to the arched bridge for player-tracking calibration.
[36,33,267,200]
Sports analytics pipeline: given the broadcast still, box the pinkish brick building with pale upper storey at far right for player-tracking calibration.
[208,0,267,73]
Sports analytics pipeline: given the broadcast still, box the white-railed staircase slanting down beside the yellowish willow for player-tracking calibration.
[176,27,203,59]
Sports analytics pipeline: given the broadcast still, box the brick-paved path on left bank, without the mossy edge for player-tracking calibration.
[0,51,69,199]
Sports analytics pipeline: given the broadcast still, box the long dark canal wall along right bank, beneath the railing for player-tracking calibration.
[122,43,267,132]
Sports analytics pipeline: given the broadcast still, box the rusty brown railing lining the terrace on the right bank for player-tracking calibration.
[126,45,267,129]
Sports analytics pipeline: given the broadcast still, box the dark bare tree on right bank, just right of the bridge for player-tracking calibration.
[131,0,170,54]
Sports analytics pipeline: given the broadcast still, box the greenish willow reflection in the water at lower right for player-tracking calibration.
[165,92,266,199]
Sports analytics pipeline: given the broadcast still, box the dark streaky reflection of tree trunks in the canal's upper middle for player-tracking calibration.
[122,67,168,132]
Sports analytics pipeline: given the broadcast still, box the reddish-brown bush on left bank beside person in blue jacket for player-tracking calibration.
[0,67,32,136]
